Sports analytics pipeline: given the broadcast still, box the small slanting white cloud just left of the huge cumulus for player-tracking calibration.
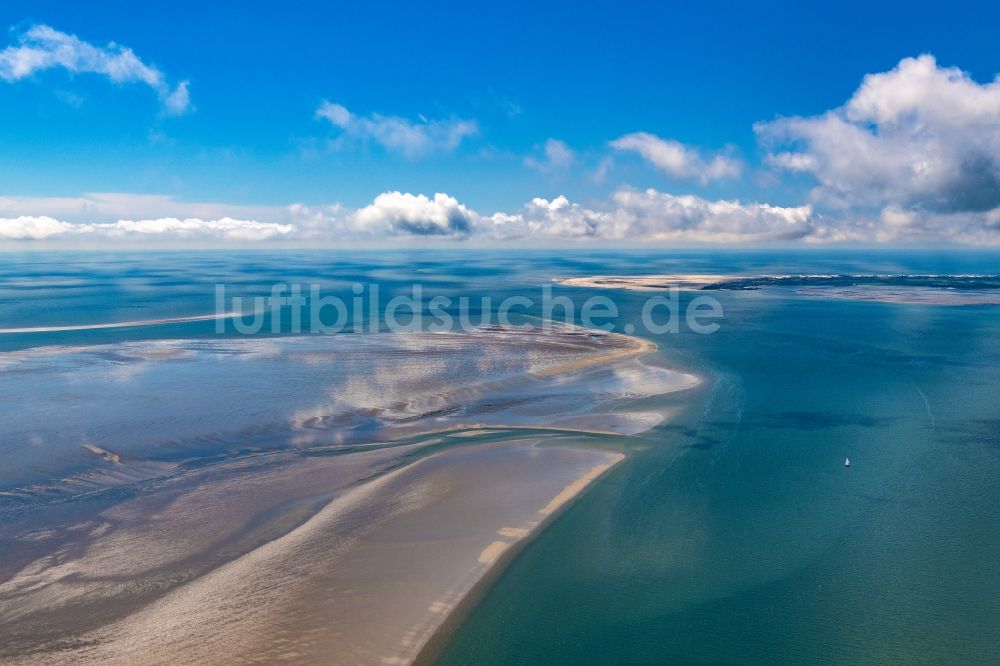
[611,132,743,184]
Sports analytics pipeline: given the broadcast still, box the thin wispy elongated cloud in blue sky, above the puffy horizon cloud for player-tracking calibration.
[316,100,479,158]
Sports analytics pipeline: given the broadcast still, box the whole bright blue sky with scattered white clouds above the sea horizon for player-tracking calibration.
[0,0,1000,244]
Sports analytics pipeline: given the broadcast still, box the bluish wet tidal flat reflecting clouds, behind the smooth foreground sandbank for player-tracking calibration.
[0,329,660,490]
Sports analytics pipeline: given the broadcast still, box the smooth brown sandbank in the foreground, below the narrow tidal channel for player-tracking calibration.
[4,440,622,664]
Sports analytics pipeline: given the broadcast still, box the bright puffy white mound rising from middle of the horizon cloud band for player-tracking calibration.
[351,192,478,237]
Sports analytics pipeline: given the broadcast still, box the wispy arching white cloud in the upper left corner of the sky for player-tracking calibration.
[0,25,191,115]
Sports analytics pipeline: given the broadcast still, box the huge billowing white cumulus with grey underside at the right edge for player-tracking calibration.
[756,55,1000,215]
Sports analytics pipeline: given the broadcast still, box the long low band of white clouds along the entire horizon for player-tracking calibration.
[7,188,1000,247]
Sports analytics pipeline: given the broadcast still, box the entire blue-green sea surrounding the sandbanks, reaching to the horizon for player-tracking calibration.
[0,252,1000,664]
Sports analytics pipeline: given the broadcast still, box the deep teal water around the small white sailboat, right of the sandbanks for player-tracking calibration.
[441,258,1000,664]
